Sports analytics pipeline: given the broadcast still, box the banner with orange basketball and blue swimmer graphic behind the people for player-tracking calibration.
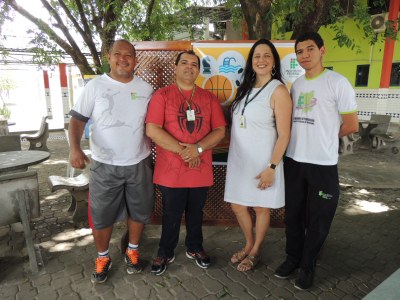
[192,41,304,157]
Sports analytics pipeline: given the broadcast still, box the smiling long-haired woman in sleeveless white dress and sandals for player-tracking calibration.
[225,39,292,272]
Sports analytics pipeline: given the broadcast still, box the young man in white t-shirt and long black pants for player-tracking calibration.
[275,32,358,290]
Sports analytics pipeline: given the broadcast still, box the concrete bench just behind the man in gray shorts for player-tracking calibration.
[48,167,89,227]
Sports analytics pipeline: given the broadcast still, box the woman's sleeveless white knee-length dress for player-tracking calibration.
[224,79,285,208]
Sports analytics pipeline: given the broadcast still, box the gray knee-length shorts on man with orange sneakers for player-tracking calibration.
[89,155,154,229]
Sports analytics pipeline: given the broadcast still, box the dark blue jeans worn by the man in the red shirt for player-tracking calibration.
[158,186,208,257]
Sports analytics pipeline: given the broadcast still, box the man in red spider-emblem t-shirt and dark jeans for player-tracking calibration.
[146,51,226,275]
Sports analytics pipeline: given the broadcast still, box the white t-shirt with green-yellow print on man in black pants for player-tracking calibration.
[286,69,357,165]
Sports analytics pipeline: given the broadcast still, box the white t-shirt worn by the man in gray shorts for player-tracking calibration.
[72,74,153,166]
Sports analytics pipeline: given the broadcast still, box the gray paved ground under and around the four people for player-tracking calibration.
[0,132,400,300]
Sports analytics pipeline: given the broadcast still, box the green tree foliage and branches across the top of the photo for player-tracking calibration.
[0,0,398,74]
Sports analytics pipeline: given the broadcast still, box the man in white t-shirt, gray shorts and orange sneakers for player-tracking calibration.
[69,40,154,283]
